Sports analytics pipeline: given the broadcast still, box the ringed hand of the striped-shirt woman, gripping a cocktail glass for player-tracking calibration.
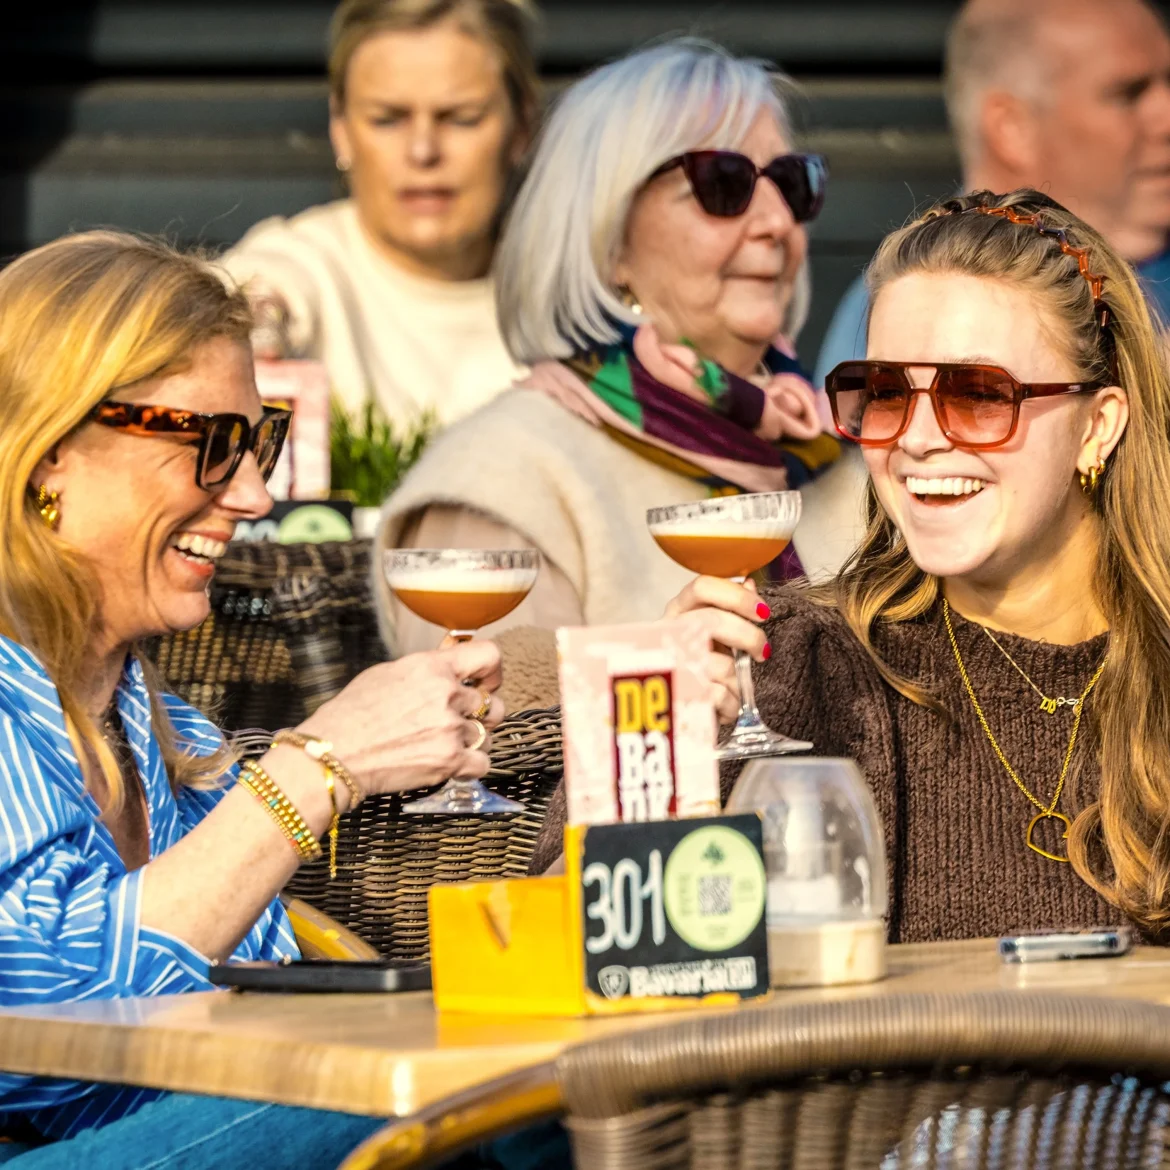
[287,641,504,796]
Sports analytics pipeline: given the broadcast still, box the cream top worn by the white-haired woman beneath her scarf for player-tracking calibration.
[374,390,865,651]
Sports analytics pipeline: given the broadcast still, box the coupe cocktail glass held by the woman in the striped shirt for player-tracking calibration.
[383,549,541,814]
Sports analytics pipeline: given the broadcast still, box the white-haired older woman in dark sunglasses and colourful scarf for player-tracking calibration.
[379,41,860,652]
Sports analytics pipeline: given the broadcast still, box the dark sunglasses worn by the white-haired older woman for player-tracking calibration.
[647,150,828,223]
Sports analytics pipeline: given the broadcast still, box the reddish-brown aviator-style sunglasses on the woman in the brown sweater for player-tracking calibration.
[825,362,1109,450]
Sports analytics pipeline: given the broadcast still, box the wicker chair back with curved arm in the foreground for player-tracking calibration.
[343,992,1170,1170]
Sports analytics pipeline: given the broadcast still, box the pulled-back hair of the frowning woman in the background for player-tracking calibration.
[329,0,541,130]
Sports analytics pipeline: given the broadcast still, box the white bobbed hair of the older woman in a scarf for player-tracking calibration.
[495,40,807,365]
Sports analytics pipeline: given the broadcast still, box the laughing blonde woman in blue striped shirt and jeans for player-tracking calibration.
[0,232,502,1170]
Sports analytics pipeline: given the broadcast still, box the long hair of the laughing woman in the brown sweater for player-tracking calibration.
[814,191,1170,936]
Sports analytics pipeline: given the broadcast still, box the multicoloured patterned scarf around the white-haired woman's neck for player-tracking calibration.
[521,323,841,577]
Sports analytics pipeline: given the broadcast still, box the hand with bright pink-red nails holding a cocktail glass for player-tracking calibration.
[665,577,772,725]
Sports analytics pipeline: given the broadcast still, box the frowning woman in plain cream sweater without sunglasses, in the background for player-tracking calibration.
[223,0,538,427]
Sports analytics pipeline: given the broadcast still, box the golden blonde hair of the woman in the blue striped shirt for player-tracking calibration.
[0,232,252,812]
